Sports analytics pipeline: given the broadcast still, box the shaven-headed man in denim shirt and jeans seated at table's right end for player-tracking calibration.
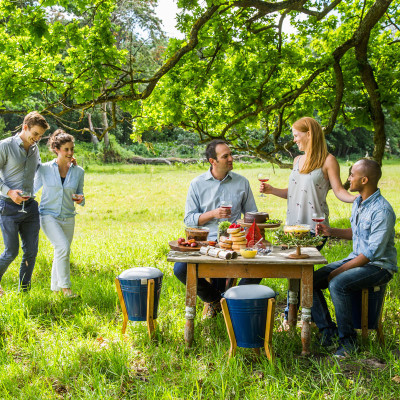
[311,159,397,357]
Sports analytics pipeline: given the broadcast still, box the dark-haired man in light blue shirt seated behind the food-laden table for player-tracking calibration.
[174,139,257,317]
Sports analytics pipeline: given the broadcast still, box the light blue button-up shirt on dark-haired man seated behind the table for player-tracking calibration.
[184,170,257,240]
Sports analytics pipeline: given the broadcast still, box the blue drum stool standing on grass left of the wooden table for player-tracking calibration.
[115,267,163,338]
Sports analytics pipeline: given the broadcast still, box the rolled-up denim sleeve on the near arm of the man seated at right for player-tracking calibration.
[362,209,395,262]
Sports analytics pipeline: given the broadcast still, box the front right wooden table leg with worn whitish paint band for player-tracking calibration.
[301,266,314,356]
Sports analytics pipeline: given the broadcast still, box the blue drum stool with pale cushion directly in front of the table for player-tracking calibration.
[221,285,277,361]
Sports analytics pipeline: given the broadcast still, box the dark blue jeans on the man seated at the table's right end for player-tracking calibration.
[311,260,393,342]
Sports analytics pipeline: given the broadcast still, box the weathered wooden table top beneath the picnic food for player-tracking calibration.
[167,246,327,265]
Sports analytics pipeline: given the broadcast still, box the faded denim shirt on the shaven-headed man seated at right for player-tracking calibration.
[348,189,397,272]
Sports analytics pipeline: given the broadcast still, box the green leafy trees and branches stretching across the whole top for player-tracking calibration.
[0,0,400,163]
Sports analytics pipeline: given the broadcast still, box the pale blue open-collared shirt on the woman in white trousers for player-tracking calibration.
[34,159,85,218]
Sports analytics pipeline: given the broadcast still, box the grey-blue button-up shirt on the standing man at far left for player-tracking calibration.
[0,134,40,198]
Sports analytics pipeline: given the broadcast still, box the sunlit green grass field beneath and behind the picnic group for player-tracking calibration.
[0,161,400,400]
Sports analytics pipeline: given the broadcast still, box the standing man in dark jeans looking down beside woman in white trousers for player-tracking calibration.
[0,111,49,296]
